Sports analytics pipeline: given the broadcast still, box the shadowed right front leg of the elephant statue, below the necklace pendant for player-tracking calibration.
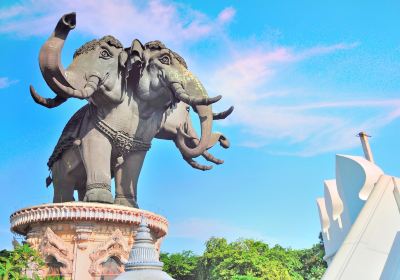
[114,152,146,208]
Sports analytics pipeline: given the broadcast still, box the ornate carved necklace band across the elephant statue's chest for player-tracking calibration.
[89,106,151,165]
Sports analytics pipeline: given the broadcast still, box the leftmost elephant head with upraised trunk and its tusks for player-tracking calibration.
[30,13,128,108]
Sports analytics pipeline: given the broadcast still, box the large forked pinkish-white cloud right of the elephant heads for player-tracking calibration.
[204,43,400,156]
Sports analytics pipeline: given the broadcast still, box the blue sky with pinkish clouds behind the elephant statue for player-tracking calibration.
[0,0,400,252]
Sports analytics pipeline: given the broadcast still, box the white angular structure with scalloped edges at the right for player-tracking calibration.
[317,133,400,280]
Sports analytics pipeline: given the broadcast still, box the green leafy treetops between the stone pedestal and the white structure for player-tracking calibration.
[161,237,326,280]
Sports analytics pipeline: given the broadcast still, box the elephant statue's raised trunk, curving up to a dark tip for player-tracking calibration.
[39,13,76,99]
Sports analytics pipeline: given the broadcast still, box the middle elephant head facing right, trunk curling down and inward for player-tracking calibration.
[131,40,221,158]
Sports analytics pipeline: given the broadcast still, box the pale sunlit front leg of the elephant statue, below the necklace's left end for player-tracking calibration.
[80,128,113,203]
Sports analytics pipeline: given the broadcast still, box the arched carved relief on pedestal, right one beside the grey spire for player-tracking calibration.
[89,229,130,277]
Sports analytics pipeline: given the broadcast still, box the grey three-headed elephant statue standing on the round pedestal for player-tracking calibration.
[30,13,231,207]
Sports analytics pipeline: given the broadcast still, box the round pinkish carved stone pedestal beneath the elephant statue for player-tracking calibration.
[10,202,168,279]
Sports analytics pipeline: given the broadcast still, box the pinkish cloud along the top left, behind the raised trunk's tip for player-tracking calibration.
[0,0,235,46]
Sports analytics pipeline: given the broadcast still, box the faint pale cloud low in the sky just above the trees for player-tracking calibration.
[168,218,277,243]
